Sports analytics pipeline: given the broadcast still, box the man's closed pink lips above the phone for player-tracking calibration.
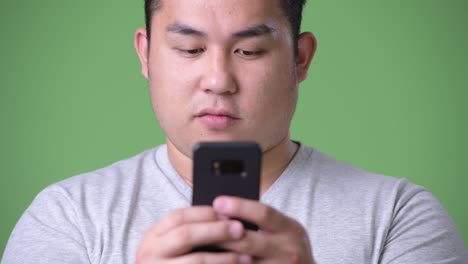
[195,109,240,130]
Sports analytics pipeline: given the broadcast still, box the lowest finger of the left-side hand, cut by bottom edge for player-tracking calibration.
[171,252,252,264]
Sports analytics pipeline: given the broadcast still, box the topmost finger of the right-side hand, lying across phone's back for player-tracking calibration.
[213,196,292,232]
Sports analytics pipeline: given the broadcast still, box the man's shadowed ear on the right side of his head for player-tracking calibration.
[296,32,317,82]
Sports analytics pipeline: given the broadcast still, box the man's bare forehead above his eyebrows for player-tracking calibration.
[152,0,288,33]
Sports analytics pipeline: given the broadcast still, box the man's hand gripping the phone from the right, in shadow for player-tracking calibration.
[213,196,313,264]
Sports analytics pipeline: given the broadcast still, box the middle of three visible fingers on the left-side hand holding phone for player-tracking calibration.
[154,221,245,257]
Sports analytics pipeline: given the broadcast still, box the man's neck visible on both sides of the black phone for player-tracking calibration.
[167,135,298,195]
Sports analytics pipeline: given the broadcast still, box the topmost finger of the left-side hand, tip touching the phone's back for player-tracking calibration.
[153,206,219,236]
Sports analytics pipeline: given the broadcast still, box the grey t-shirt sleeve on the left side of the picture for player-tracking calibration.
[2,186,90,264]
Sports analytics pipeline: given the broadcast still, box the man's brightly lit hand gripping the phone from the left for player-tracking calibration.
[136,206,251,264]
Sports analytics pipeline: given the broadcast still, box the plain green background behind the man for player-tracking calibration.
[0,0,468,252]
